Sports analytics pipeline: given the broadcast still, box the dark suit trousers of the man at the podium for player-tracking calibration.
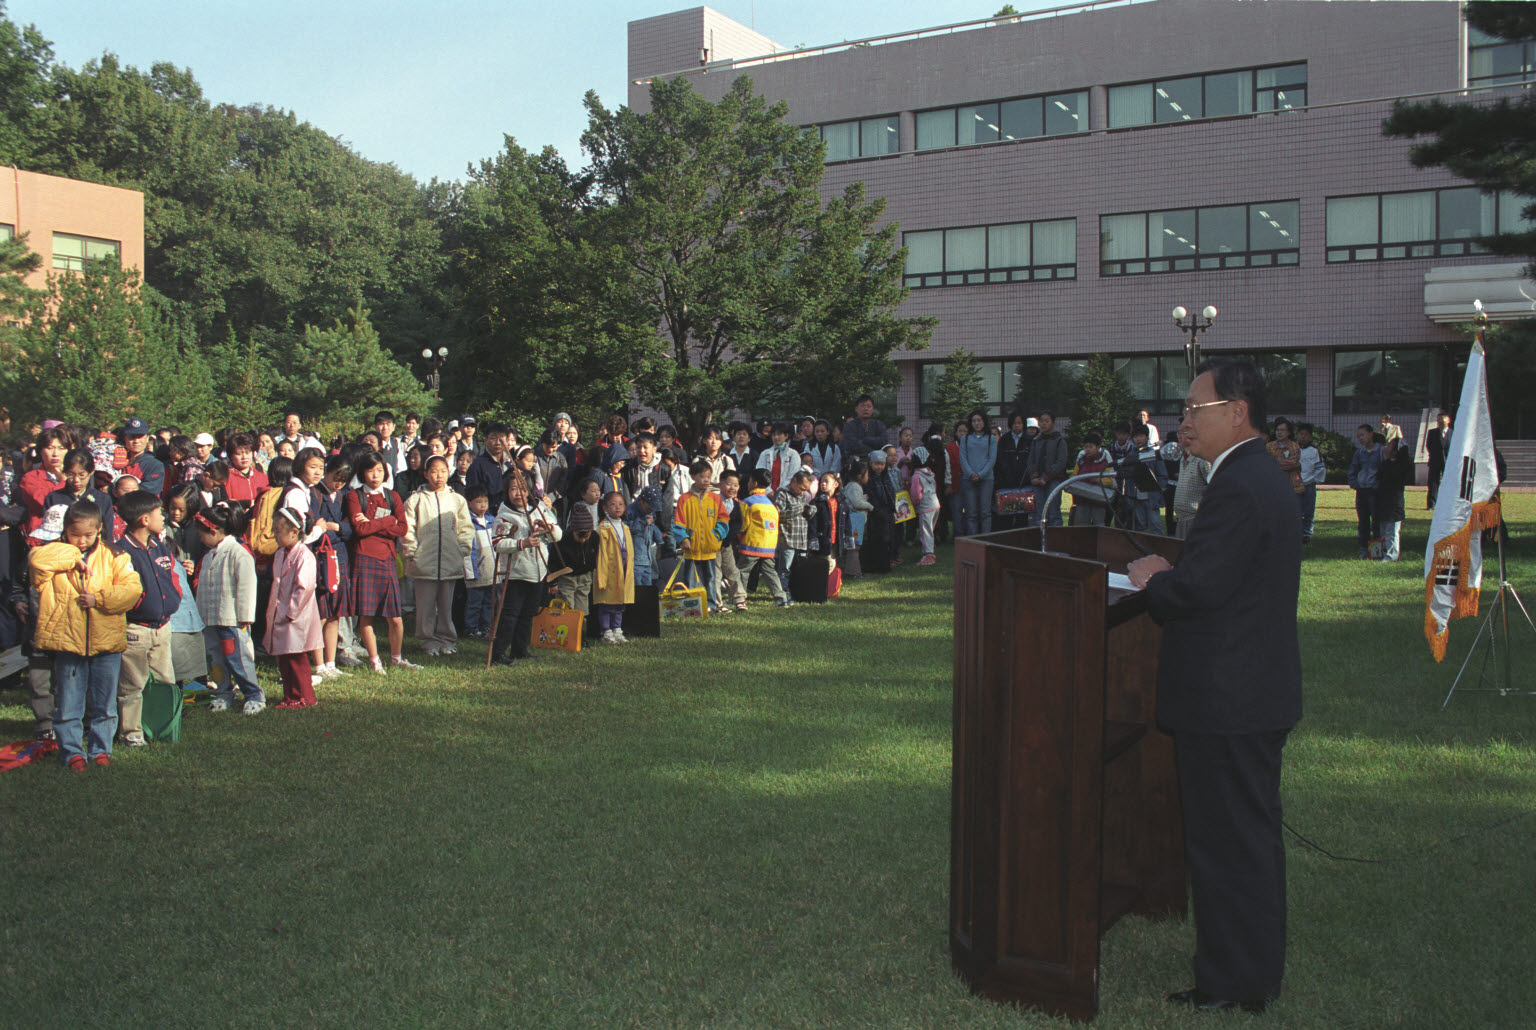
[1174,729,1289,1001]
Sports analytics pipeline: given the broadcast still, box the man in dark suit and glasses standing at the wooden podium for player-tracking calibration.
[1129,359,1301,1012]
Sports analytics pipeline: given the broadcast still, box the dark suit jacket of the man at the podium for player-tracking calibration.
[1146,437,1301,734]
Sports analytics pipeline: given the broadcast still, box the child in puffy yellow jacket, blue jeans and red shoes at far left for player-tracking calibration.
[28,500,144,772]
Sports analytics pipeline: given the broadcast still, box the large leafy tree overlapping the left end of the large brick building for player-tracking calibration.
[582,77,932,442]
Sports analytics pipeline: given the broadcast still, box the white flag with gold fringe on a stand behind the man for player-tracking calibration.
[1424,337,1499,662]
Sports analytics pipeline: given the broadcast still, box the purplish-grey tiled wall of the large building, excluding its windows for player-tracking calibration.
[631,0,1517,439]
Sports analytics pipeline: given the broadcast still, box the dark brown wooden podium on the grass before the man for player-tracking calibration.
[949,527,1184,1019]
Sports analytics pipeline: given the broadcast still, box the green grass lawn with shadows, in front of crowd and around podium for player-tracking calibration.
[0,491,1536,1028]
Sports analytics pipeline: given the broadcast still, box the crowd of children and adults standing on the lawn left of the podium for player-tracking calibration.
[12,396,1302,768]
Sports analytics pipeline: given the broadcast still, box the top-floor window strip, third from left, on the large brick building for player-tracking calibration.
[1107,64,1307,129]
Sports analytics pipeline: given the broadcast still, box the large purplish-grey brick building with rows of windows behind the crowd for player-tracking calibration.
[628,0,1533,439]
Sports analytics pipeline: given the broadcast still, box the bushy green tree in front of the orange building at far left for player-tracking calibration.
[14,261,214,428]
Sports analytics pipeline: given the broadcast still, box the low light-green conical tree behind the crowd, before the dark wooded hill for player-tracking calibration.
[278,307,435,424]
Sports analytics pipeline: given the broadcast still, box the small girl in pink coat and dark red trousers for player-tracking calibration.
[263,508,323,708]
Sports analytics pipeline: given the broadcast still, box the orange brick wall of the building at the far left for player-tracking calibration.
[0,167,144,287]
